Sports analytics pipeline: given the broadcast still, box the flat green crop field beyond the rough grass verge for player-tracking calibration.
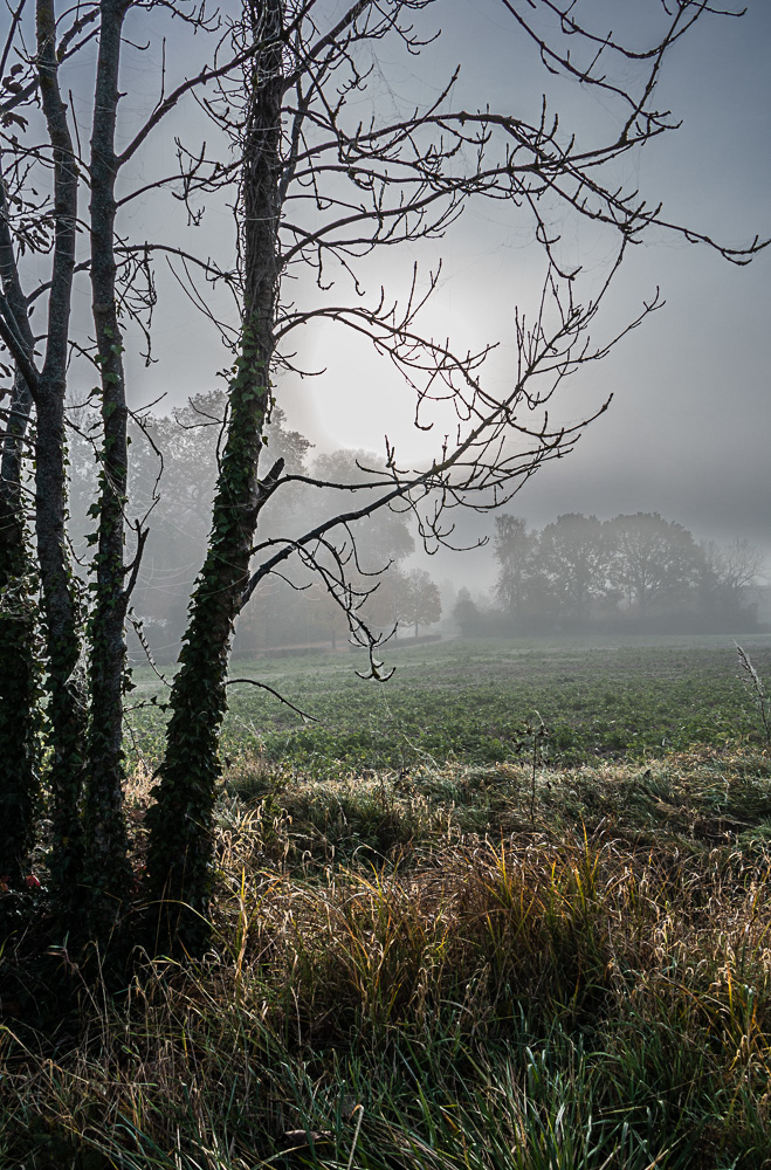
[132,636,771,776]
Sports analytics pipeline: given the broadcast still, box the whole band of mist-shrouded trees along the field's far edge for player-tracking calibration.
[70,394,771,662]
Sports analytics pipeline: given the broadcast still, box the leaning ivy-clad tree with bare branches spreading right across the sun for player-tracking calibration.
[143,0,758,937]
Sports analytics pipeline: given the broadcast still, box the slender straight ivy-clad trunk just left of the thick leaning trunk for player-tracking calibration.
[83,0,131,941]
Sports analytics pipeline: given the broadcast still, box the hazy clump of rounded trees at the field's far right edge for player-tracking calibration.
[454,512,760,634]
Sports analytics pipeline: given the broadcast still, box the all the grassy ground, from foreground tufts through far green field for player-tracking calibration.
[0,638,771,1170]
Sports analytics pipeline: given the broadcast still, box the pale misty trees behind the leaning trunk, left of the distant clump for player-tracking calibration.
[70,391,441,663]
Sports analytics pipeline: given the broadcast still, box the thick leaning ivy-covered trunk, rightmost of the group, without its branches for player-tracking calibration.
[147,0,283,952]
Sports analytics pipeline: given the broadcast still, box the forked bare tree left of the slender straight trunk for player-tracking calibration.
[0,0,94,903]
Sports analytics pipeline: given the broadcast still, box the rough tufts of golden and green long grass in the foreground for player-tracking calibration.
[0,751,771,1170]
